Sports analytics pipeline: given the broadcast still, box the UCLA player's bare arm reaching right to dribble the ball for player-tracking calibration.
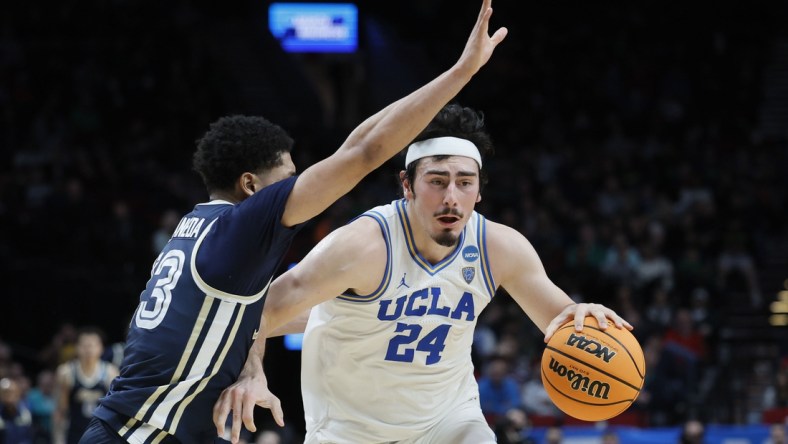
[487,222,632,342]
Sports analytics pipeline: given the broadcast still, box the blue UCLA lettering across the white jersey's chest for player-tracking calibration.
[378,287,476,321]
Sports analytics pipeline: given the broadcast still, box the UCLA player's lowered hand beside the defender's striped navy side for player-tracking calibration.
[213,370,285,444]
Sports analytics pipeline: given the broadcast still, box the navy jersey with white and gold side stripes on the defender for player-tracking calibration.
[95,177,300,443]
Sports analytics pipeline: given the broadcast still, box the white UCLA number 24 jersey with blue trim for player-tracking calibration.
[301,200,495,443]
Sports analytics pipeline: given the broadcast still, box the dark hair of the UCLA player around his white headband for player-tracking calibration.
[405,103,494,190]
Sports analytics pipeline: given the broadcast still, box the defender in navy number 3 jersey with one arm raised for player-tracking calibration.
[81,0,507,444]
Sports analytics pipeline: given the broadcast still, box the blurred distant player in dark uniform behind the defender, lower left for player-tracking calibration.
[52,327,118,444]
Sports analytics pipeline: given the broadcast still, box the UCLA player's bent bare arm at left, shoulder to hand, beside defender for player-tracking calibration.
[213,217,387,442]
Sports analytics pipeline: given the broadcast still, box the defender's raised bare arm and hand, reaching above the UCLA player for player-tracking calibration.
[282,0,508,226]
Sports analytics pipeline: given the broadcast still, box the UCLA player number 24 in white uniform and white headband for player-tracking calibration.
[214,104,632,444]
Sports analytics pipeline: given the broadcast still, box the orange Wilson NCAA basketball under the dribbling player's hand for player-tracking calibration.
[542,316,646,421]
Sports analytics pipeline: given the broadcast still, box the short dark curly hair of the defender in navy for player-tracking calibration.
[192,115,293,192]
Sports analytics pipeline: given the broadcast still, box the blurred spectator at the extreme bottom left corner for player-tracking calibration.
[0,378,33,444]
